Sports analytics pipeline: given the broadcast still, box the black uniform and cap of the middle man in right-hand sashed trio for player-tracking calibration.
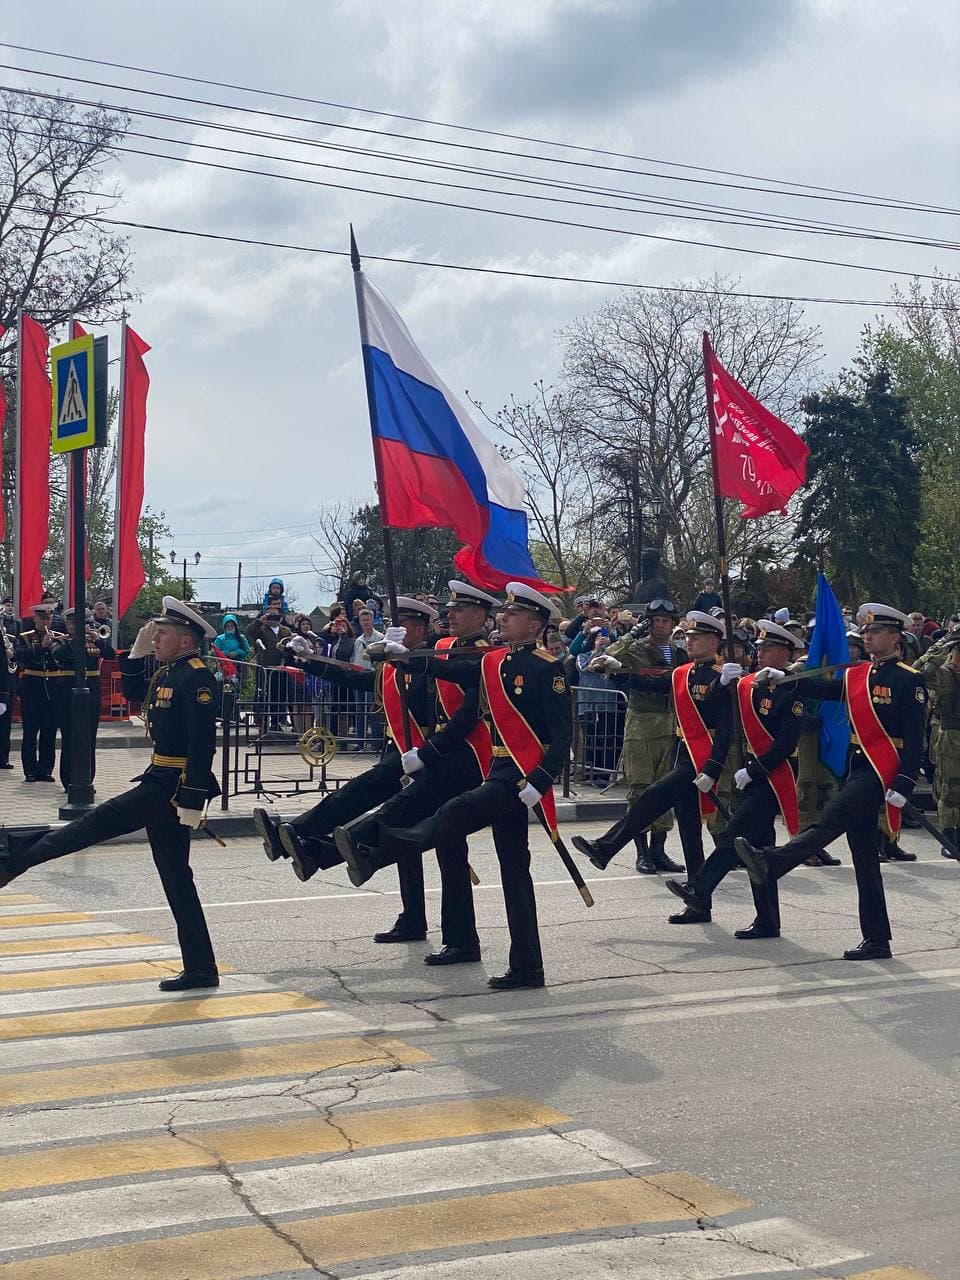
[666,622,804,940]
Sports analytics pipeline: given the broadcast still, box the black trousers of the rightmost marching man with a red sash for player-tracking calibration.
[765,748,891,942]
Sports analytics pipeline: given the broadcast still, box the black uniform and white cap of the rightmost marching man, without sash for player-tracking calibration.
[736,604,927,960]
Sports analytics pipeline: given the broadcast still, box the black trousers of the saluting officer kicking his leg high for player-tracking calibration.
[10,768,216,973]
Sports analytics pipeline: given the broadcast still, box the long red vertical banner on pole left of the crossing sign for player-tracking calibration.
[17,315,51,617]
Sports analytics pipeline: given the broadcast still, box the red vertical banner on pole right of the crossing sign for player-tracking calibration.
[114,325,150,622]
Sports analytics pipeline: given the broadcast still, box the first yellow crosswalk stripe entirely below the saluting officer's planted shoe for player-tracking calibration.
[0,991,326,1041]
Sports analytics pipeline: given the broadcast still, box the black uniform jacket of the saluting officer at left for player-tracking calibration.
[120,654,220,809]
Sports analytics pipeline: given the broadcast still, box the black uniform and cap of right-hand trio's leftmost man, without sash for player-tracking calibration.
[572,613,732,906]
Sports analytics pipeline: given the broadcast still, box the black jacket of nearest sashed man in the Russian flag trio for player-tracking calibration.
[406,641,572,795]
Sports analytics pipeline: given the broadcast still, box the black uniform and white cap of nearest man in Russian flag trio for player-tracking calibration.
[351,582,572,988]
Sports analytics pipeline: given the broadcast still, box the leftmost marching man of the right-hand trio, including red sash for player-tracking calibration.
[572,609,742,924]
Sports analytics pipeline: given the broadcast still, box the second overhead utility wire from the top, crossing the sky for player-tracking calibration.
[0,63,960,215]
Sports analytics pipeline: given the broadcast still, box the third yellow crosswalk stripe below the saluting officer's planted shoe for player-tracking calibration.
[0,1098,568,1193]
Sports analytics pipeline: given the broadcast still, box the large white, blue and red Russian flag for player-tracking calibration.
[357,271,558,591]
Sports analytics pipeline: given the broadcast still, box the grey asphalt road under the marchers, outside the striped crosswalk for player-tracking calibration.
[0,827,960,1280]
